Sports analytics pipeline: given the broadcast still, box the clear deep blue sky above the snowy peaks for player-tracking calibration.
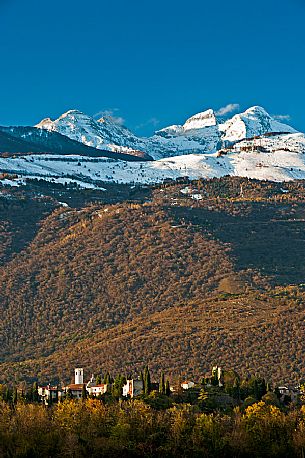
[0,0,305,135]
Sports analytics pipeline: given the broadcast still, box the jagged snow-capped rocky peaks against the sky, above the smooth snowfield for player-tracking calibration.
[36,106,296,159]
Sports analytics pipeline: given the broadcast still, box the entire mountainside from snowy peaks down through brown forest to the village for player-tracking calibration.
[0,107,305,383]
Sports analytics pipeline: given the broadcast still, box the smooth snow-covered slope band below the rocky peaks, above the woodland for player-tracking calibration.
[0,133,305,188]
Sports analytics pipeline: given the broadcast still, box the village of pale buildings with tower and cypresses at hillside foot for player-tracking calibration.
[37,366,305,406]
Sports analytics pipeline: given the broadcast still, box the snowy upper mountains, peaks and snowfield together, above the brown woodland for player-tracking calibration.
[0,106,305,188]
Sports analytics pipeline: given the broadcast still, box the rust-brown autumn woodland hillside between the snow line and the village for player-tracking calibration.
[0,178,305,383]
